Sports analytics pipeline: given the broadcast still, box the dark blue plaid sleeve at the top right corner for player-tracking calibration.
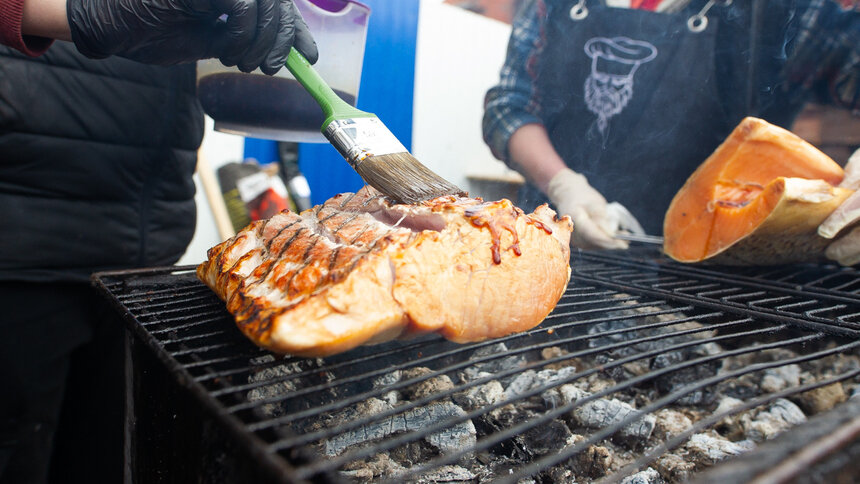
[786,0,860,114]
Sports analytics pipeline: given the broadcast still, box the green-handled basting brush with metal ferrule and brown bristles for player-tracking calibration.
[287,48,464,203]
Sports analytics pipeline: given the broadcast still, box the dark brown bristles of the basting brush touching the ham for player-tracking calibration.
[355,152,465,203]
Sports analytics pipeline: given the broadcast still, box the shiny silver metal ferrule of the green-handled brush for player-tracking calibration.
[323,118,407,167]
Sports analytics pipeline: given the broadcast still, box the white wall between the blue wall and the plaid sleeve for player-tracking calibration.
[412,0,518,195]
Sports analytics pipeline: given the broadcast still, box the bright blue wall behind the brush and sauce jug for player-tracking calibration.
[245,0,419,204]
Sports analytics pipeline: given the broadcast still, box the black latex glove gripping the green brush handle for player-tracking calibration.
[66,0,319,74]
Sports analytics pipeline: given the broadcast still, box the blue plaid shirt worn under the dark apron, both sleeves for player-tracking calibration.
[483,0,860,165]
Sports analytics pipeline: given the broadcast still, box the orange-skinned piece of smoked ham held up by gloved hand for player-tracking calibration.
[663,118,853,265]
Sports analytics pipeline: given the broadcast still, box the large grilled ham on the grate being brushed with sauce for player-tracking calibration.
[197,188,572,356]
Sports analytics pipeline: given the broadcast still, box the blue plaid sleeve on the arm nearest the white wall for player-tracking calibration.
[482,0,545,164]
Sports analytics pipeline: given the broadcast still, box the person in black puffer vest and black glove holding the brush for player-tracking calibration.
[0,0,318,483]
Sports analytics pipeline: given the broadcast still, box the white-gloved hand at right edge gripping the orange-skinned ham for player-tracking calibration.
[818,150,860,266]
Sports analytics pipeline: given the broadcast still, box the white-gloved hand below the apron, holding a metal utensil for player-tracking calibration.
[547,168,642,249]
